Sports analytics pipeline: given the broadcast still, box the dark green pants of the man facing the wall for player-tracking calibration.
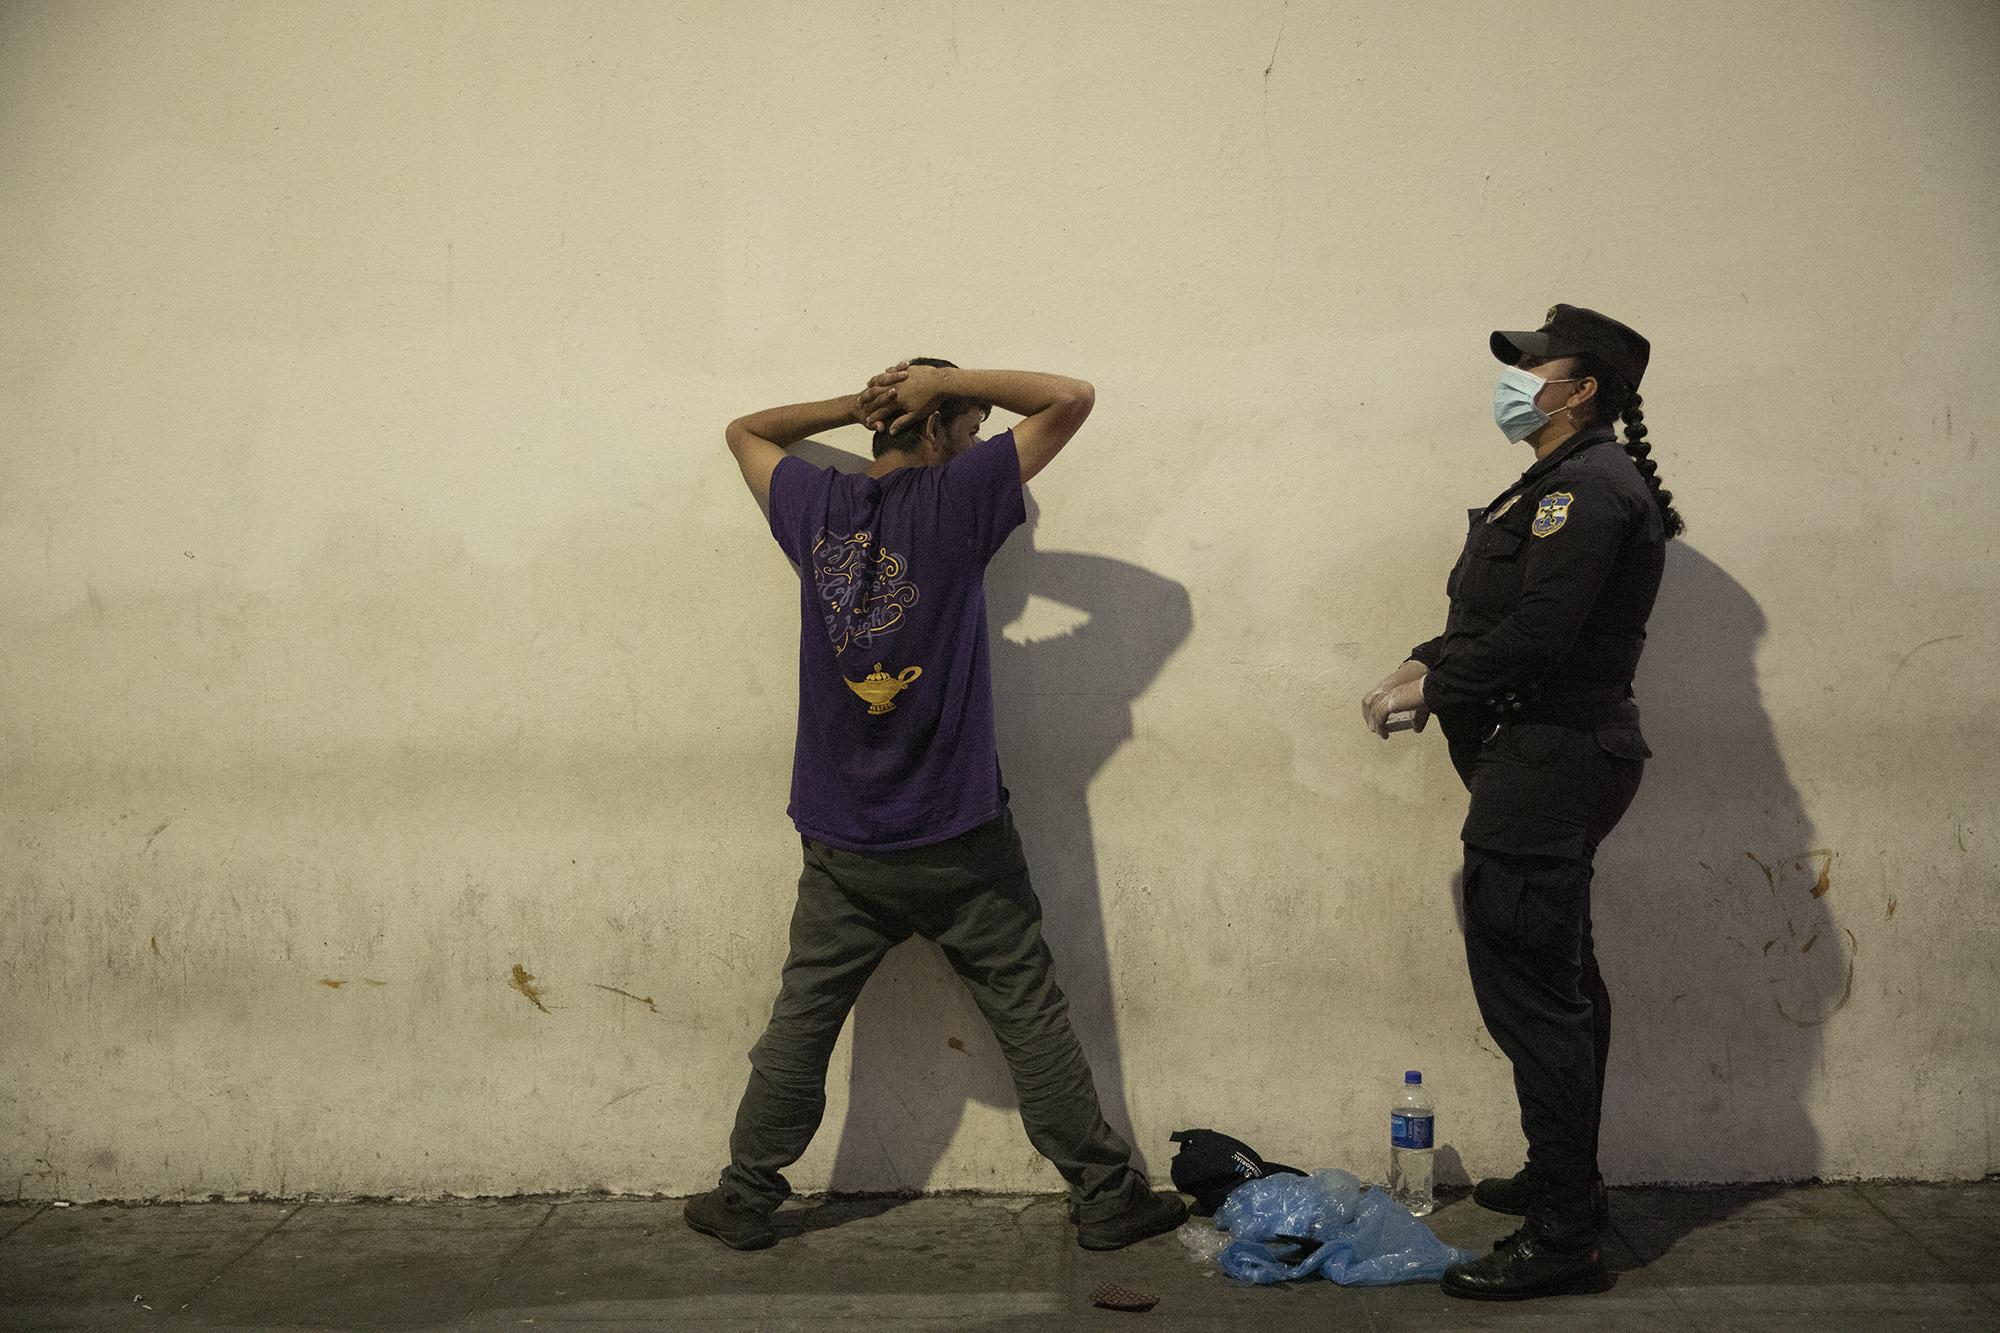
[722,815,1148,1221]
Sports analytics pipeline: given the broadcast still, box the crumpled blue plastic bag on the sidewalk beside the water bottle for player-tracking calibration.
[1216,1171,1474,1287]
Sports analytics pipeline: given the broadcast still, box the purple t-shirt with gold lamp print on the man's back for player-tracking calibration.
[770,430,1028,851]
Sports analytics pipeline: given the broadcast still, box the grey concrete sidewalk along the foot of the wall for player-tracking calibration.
[0,1179,2000,1333]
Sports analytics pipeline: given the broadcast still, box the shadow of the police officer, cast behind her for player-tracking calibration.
[1592,542,1840,1267]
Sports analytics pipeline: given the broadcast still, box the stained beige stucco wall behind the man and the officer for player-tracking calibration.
[0,0,2000,1199]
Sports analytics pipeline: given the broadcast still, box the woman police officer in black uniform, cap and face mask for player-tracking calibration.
[1362,306,1682,1299]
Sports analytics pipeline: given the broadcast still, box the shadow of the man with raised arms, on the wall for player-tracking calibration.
[798,446,1192,1191]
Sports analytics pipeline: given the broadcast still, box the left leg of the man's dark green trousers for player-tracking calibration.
[722,841,910,1209]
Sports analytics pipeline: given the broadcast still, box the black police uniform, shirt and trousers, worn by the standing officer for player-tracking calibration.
[1410,418,1666,1239]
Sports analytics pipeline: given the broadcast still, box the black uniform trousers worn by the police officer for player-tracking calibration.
[1446,711,1646,1241]
